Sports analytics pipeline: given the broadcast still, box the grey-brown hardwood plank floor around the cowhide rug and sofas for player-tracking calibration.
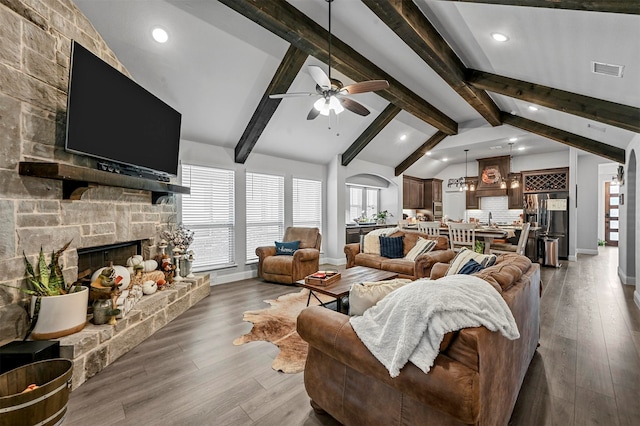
[64,247,640,426]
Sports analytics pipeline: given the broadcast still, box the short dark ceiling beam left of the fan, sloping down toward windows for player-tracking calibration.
[235,45,308,164]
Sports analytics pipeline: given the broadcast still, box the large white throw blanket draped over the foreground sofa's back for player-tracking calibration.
[349,275,520,377]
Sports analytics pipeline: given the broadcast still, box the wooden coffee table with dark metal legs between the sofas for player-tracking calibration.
[296,266,398,312]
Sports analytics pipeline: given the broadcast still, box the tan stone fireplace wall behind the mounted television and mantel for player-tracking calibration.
[0,0,175,344]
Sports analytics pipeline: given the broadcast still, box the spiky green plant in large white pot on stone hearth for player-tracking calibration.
[21,241,89,340]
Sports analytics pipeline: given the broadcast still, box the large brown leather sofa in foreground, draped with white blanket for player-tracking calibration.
[298,254,540,426]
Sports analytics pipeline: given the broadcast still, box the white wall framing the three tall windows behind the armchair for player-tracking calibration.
[180,140,328,284]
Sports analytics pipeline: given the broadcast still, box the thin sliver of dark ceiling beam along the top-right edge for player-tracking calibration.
[440,0,640,15]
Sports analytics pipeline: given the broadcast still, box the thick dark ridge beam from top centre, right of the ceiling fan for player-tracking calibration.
[362,0,502,126]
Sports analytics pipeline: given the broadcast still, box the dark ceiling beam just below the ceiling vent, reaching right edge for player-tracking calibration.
[467,70,640,133]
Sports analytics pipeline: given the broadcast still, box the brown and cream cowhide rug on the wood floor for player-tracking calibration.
[233,288,334,373]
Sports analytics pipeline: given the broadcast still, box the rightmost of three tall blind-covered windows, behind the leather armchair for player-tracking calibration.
[293,178,322,234]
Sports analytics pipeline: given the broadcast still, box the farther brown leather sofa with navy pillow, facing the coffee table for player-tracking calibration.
[344,230,455,280]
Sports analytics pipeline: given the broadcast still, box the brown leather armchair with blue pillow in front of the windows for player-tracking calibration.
[256,226,322,284]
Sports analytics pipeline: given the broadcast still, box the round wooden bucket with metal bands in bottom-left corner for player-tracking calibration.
[0,358,73,426]
